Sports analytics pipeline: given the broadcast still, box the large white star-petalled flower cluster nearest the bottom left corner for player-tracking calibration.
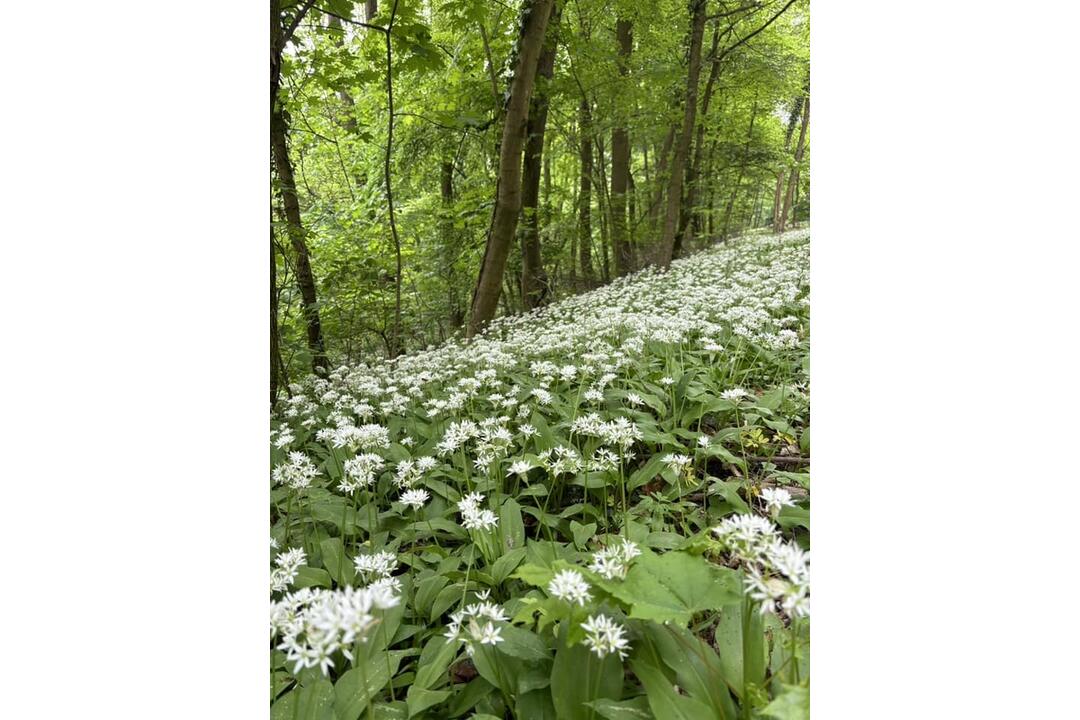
[270,586,400,675]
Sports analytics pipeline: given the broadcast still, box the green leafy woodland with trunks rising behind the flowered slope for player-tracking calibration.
[270,0,809,402]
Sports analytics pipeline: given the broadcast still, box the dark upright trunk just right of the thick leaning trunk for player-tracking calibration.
[518,0,562,310]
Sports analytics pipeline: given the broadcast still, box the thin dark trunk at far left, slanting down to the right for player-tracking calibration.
[270,0,328,371]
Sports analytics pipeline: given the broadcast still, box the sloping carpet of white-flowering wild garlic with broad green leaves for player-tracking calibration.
[270,230,810,720]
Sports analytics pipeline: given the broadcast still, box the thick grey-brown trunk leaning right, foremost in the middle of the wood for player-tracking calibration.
[468,0,553,338]
